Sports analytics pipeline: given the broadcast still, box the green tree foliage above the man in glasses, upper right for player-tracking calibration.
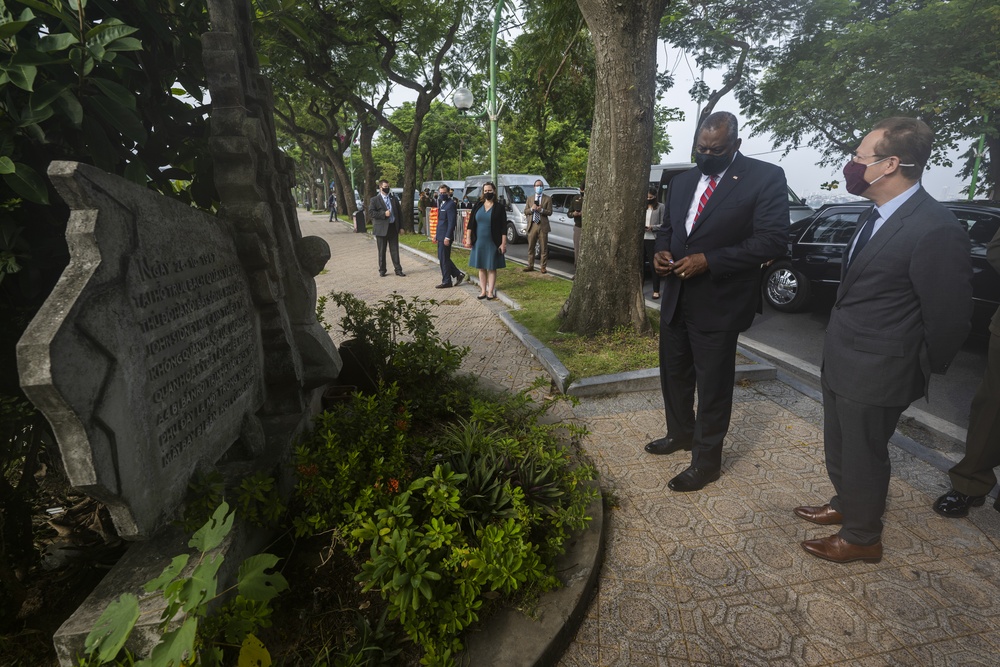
[747,0,1000,197]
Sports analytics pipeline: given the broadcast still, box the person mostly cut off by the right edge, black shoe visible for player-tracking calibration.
[932,227,1000,519]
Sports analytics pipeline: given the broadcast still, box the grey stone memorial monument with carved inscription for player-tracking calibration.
[18,0,341,665]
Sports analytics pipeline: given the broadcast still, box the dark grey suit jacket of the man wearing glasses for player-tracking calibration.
[823,188,972,407]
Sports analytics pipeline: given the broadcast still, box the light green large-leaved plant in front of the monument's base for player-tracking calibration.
[84,502,288,667]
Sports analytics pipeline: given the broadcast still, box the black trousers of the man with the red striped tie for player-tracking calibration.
[660,294,740,470]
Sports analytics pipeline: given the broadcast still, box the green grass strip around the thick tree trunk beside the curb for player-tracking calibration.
[399,234,660,379]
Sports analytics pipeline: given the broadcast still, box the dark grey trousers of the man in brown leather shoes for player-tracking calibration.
[822,378,906,545]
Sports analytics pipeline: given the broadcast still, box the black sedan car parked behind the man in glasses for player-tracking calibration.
[764,201,1000,333]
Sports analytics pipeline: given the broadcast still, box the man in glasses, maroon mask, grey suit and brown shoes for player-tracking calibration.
[795,118,972,563]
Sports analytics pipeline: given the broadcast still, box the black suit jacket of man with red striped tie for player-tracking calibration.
[655,153,789,331]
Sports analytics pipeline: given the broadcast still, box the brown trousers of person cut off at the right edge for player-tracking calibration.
[948,334,1000,496]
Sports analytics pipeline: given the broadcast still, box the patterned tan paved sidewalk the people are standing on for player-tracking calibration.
[300,211,1000,667]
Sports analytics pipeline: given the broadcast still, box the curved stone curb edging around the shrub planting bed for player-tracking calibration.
[457,480,605,667]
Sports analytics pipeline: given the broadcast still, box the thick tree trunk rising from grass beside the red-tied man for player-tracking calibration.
[562,0,668,334]
